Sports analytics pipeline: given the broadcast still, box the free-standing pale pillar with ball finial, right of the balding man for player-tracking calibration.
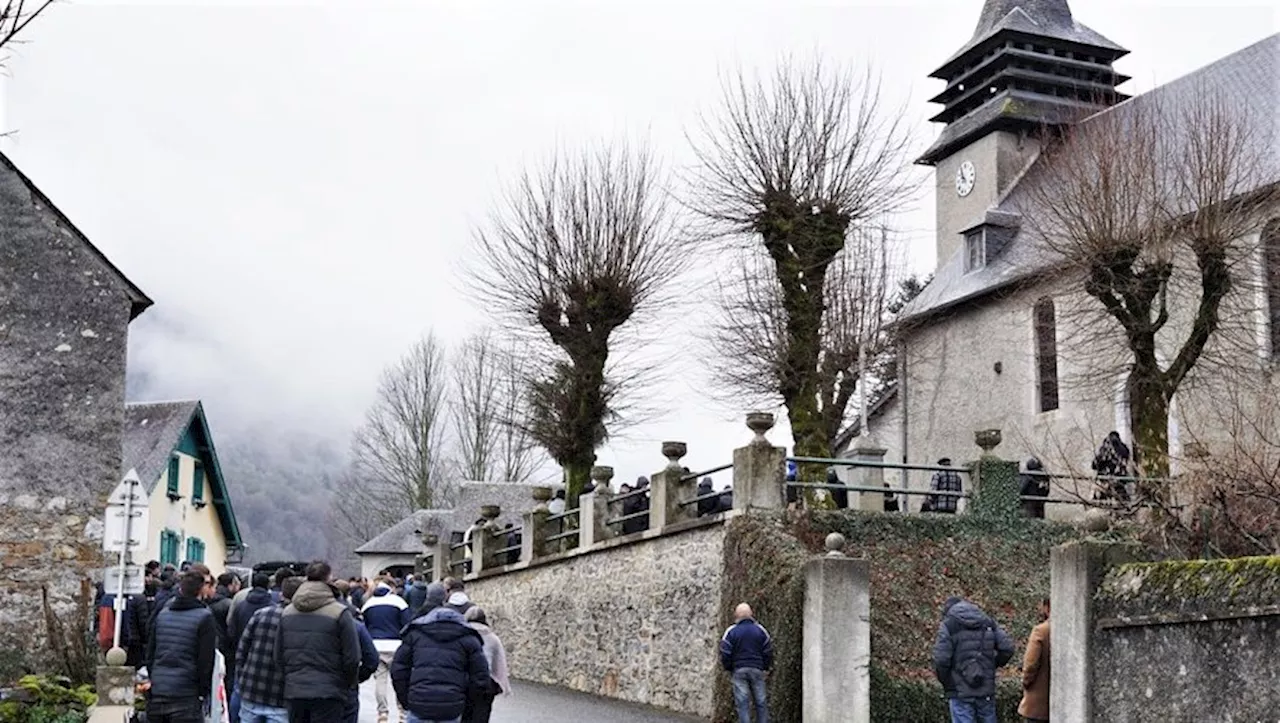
[801,532,872,723]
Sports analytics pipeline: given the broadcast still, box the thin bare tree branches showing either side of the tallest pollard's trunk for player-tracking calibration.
[708,225,897,450]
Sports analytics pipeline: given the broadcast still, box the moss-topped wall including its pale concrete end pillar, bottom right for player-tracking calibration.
[1050,543,1280,723]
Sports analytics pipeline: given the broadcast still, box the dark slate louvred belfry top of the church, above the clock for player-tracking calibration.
[919,0,1129,165]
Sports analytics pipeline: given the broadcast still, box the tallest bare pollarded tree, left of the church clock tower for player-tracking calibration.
[691,63,918,457]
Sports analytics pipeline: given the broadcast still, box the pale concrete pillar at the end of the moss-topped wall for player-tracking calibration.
[1048,540,1142,723]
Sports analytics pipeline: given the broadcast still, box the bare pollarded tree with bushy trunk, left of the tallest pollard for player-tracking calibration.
[470,148,685,499]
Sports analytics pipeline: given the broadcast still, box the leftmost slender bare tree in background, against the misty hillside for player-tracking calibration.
[352,334,453,511]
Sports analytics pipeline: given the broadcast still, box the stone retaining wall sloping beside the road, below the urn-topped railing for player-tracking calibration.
[467,521,724,718]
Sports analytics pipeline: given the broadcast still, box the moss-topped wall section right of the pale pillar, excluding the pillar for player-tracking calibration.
[1091,557,1280,723]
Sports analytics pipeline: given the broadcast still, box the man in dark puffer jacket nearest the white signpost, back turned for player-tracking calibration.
[146,569,218,723]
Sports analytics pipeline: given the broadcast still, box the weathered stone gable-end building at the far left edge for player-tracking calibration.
[0,149,151,671]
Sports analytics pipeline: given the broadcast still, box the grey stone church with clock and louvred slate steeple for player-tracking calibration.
[870,0,1280,514]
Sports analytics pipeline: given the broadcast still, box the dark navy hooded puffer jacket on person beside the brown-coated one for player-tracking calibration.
[933,600,1014,699]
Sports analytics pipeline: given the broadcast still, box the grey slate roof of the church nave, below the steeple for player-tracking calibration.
[897,33,1280,322]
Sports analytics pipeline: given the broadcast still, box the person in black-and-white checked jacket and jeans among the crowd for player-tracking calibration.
[233,577,303,723]
